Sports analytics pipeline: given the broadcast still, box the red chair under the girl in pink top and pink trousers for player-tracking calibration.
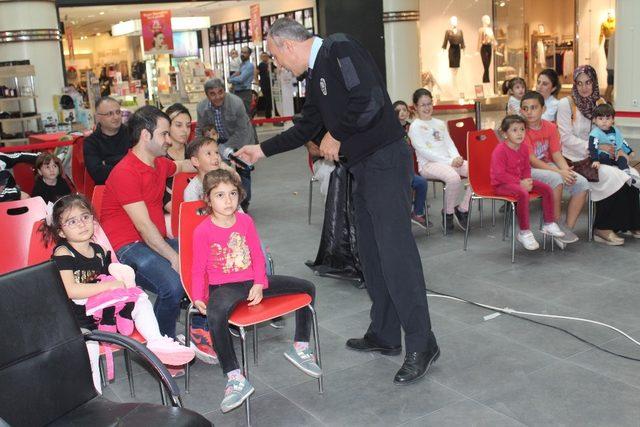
[464,129,553,262]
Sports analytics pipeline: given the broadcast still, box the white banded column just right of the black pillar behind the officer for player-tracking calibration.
[382,0,422,104]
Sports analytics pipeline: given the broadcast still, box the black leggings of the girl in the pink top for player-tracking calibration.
[207,276,316,374]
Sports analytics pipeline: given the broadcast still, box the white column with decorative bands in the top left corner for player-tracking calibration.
[0,0,64,112]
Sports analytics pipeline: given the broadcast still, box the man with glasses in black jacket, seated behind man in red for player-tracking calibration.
[84,96,131,185]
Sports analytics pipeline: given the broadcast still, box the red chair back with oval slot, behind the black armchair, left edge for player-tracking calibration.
[0,197,46,274]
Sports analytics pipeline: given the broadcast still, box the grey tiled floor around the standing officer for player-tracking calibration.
[99,122,640,426]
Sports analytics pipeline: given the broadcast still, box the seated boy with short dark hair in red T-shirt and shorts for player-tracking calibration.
[520,91,589,249]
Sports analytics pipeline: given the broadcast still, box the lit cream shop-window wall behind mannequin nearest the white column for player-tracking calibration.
[420,0,493,100]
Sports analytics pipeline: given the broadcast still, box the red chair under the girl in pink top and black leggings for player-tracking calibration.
[178,200,323,425]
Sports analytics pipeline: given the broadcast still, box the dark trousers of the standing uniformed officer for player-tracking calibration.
[350,140,436,352]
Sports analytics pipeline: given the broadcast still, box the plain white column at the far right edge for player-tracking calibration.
[614,0,640,112]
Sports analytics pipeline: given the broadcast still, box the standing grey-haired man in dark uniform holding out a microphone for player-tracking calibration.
[236,18,440,385]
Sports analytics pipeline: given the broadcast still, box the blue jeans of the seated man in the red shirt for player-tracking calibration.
[116,239,206,338]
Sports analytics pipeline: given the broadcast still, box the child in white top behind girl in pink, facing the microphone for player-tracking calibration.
[184,137,237,202]
